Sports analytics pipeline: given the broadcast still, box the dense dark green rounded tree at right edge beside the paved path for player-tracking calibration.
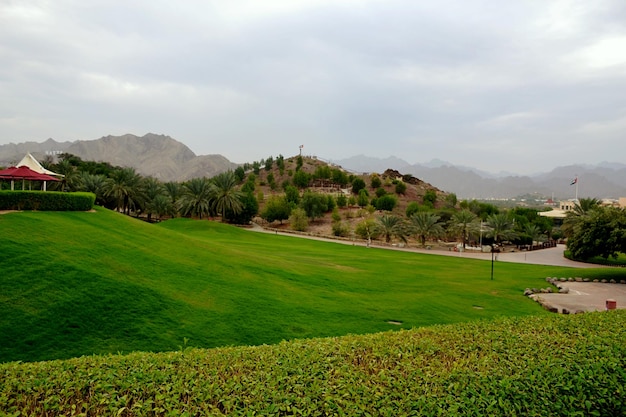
[567,206,626,260]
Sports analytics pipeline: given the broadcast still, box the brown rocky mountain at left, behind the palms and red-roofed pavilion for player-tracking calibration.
[0,133,237,181]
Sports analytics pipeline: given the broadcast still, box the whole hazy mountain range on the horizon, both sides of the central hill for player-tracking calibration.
[0,133,626,199]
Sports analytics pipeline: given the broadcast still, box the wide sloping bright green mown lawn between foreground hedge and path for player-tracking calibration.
[0,209,626,361]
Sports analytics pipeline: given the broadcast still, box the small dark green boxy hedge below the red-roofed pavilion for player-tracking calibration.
[0,191,96,211]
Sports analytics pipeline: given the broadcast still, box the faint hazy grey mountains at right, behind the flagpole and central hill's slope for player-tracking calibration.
[334,156,626,199]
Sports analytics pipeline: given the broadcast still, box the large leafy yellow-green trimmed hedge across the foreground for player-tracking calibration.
[0,310,626,417]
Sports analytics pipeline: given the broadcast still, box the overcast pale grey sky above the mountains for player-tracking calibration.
[0,0,626,174]
